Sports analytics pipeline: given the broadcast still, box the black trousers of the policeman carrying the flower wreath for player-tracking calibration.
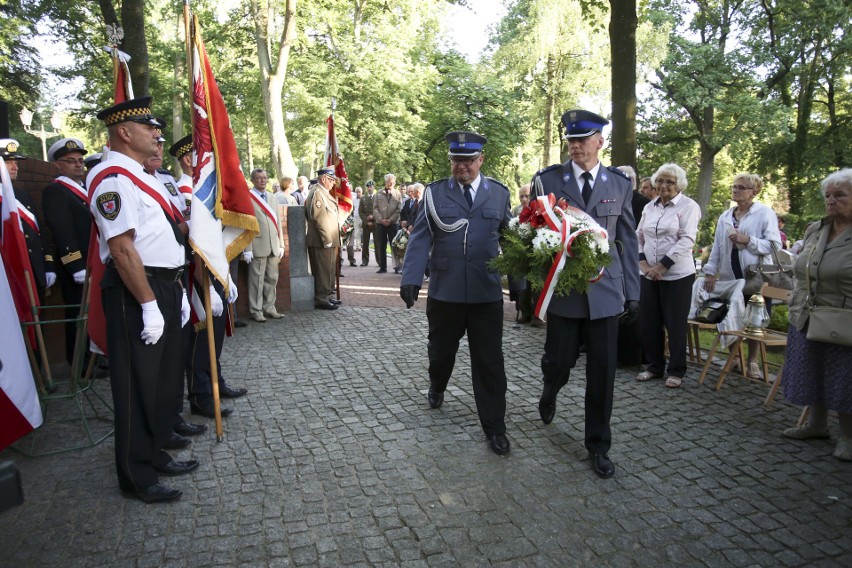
[542,313,618,454]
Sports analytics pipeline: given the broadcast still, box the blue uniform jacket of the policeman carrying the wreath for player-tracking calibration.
[532,161,639,319]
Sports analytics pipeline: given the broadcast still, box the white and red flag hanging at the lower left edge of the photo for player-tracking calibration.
[0,245,42,450]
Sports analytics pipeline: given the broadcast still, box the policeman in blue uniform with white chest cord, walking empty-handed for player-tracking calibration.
[400,132,510,455]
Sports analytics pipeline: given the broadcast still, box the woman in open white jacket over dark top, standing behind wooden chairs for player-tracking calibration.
[704,173,781,379]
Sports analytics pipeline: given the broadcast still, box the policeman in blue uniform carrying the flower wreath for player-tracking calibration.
[532,110,639,478]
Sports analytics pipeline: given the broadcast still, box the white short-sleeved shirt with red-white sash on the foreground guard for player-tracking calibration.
[86,150,186,268]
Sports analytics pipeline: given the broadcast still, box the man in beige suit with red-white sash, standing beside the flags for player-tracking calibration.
[243,168,284,322]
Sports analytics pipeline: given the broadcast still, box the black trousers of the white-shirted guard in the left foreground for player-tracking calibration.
[101,267,183,491]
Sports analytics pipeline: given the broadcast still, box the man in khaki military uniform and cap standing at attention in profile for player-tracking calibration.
[305,167,340,310]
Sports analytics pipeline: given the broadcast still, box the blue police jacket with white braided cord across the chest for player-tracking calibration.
[401,174,510,304]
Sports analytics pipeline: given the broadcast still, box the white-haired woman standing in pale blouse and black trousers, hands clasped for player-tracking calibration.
[636,164,701,388]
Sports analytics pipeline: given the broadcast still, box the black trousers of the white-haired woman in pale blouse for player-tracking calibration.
[639,274,695,378]
